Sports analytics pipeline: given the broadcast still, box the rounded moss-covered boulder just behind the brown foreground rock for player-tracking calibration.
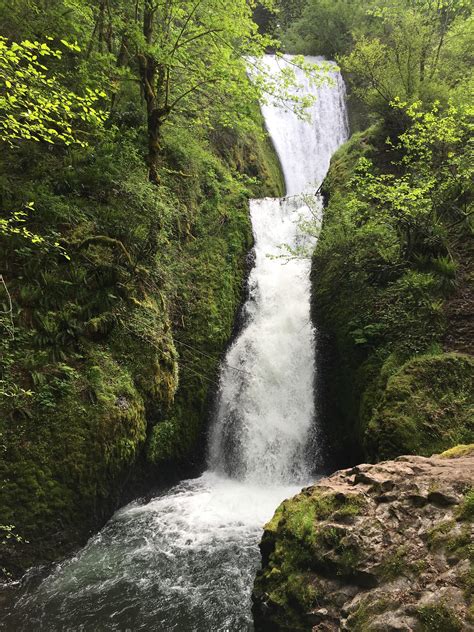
[365,353,474,459]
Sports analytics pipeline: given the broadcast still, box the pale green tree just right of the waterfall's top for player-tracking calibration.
[340,0,470,112]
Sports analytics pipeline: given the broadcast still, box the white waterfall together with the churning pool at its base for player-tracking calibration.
[0,56,347,632]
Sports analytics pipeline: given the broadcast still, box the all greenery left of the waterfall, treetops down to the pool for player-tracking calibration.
[0,0,283,572]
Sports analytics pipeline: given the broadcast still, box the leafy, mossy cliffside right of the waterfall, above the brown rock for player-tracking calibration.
[313,103,472,458]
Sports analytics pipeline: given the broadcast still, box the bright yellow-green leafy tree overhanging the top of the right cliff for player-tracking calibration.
[347,101,474,259]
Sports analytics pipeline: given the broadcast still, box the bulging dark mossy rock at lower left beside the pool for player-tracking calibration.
[0,347,146,570]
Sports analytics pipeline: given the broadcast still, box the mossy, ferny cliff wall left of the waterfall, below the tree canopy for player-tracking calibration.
[0,111,277,576]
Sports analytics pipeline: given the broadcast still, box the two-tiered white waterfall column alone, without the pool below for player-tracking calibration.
[209,56,347,483]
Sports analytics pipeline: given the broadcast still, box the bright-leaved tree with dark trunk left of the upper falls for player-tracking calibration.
[78,0,271,182]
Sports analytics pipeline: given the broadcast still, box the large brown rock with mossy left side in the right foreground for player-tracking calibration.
[253,446,474,632]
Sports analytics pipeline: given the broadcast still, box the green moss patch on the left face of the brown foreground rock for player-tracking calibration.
[254,488,366,630]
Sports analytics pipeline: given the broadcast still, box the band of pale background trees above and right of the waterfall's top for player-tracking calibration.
[283,0,473,118]
